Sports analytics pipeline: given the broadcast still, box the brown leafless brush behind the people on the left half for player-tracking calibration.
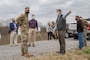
[0,26,47,45]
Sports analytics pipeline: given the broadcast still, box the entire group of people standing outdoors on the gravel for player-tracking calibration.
[9,7,88,56]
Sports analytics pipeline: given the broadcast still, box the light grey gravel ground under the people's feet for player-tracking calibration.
[0,38,90,60]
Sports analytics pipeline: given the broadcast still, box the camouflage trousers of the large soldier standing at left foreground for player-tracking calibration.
[21,30,28,55]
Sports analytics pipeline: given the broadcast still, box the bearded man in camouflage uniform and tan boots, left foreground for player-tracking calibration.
[17,7,32,57]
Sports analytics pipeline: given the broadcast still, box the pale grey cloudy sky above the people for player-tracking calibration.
[0,0,90,24]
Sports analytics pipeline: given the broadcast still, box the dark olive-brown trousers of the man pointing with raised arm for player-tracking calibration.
[58,30,66,53]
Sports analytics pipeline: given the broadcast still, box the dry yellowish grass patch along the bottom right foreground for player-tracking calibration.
[27,47,90,60]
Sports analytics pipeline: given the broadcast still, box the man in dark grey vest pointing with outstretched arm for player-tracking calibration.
[54,9,71,54]
